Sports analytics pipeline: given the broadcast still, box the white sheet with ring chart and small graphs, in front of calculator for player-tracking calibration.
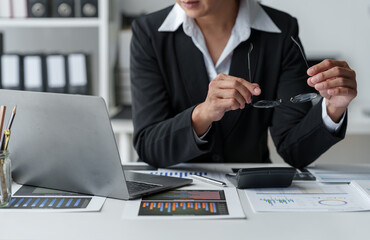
[244,182,370,212]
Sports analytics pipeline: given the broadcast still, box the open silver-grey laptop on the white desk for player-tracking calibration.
[0,90,192,200]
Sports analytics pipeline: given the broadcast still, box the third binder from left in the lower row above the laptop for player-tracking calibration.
[45,55,68,93]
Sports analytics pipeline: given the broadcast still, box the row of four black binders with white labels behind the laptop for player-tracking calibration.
[0,53,91,94]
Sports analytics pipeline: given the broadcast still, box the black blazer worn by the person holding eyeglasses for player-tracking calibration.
[131,4,346,168]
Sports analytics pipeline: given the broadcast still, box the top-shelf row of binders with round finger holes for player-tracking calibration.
[0,0,99,18]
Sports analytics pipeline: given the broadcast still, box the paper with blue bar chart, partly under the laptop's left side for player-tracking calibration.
[0,184,106,213]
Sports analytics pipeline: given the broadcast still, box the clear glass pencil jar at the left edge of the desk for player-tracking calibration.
[0,151,12,207]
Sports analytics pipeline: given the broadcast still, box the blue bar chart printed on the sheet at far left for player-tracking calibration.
[7,197,91,209]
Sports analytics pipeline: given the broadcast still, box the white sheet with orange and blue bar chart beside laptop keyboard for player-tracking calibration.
[122,187,245,219]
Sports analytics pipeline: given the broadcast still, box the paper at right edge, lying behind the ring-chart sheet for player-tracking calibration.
[309,164,370,183]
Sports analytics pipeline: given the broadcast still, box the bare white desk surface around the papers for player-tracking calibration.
[0,164,370,240]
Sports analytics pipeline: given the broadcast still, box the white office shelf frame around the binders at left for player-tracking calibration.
[0,0,119,108]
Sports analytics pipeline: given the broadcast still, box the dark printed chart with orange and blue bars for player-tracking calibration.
[139,190,229,216]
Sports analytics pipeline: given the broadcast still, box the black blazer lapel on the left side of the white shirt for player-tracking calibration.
[175,31,209,106]
